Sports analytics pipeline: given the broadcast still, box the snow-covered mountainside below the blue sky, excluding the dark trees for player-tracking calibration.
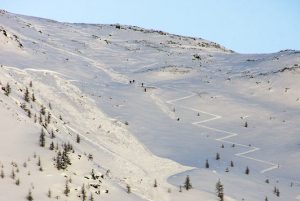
[0,11,300,201]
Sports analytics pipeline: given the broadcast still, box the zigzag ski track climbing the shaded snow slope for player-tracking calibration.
[167,93,279,174]
